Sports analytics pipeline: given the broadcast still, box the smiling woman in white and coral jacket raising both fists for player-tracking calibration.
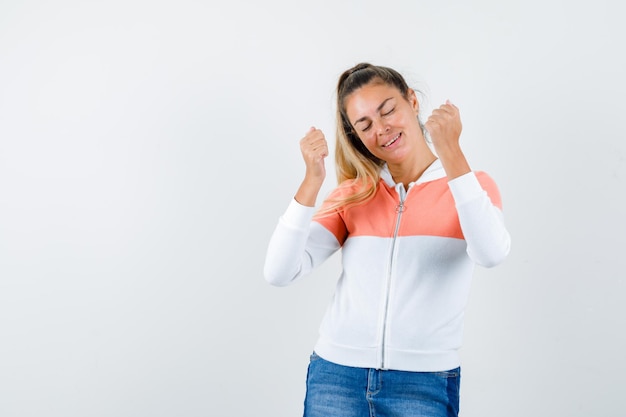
[264,63,510,417]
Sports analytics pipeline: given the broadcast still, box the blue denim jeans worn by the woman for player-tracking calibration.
[304,353,461,417]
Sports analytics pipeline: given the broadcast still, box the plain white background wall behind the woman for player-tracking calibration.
[0,0,626,417]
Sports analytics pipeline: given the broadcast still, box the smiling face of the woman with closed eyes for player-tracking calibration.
[345,83,424,163]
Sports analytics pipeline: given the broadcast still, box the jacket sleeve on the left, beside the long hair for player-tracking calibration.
[263,199,340,286]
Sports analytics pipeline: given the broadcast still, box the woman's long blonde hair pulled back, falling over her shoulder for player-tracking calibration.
[319,62,421,215]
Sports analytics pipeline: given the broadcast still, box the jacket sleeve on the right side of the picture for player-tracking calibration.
[448,172,511,267]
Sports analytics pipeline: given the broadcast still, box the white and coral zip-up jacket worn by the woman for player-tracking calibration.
[264,160,510,372]
